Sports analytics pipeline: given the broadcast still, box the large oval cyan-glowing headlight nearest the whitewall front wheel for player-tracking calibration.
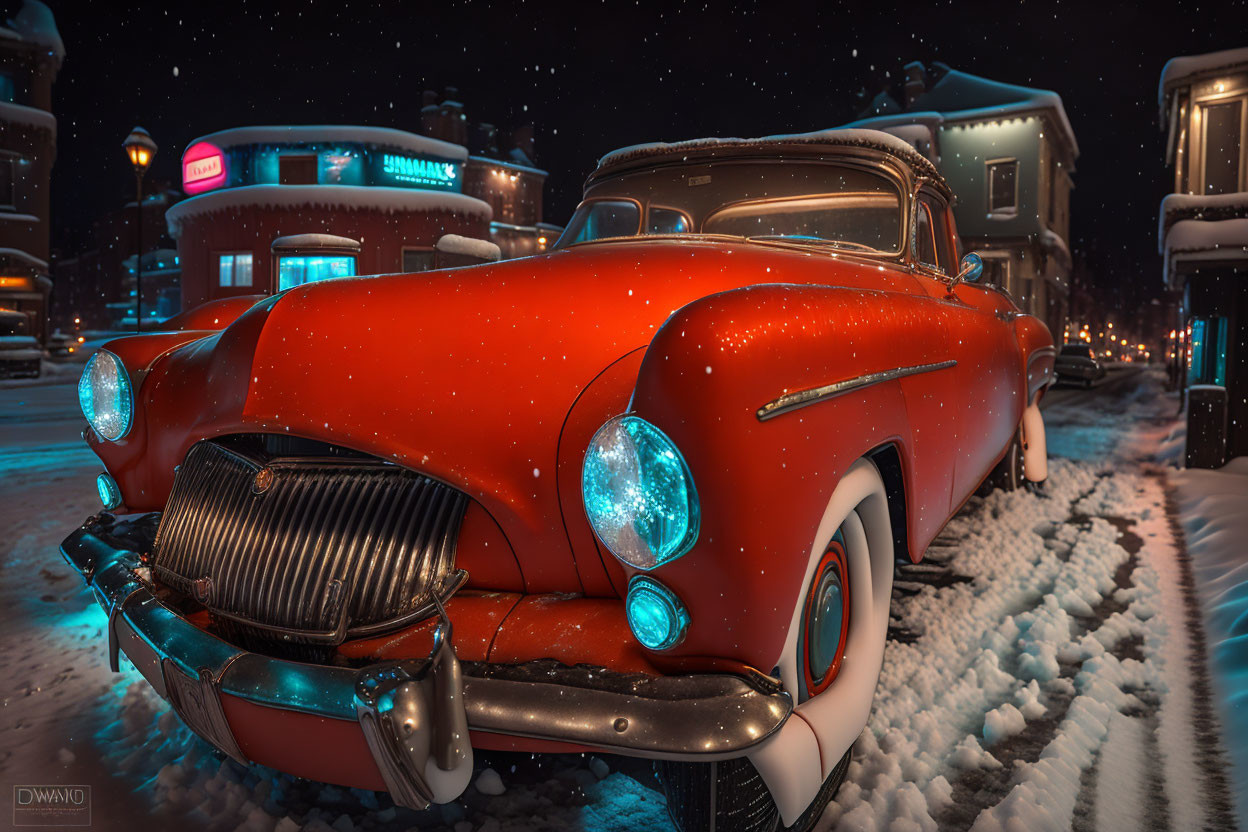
[580,415,699,569]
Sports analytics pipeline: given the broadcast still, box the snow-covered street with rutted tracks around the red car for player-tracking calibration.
[0,369,1246,832]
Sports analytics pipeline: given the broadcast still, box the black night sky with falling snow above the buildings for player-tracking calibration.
[29,0,1248,311]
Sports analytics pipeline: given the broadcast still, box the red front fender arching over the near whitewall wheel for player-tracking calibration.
[628,284,947,672]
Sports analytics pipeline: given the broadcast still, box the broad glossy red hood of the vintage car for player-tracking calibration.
[136,242,913,591]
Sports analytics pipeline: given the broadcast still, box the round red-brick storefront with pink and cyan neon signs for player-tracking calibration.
[166,125,493,308]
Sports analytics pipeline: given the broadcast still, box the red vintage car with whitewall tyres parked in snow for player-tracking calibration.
[62,131,1053,831]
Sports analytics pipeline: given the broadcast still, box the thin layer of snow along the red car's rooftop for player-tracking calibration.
[595,128,943,181]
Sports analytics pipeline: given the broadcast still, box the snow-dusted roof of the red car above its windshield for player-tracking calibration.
[587,128,948,191]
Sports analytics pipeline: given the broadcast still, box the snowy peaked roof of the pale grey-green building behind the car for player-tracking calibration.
[847,70,1080,157]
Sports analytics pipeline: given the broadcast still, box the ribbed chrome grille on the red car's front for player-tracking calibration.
[152,437,468,644]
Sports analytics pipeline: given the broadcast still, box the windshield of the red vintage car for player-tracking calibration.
[555,160,902,254]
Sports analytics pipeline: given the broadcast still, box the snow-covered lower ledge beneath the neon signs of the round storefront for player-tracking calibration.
[164,185,494,237]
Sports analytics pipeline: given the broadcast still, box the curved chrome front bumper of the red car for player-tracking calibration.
[61,518,792,791]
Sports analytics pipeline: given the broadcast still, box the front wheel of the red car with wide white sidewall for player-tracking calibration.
[655,459,892,832]
